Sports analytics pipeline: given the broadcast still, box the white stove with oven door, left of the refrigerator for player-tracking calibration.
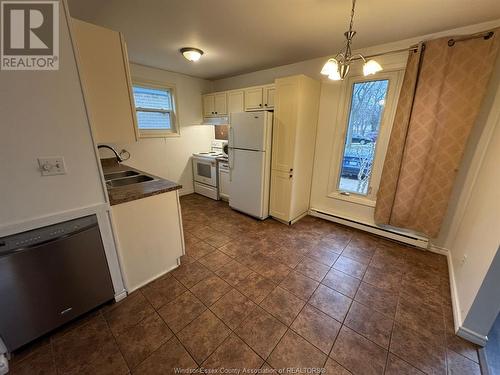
[193,140,227,200]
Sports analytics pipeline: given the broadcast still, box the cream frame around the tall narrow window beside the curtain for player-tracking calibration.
[327,69,404,207]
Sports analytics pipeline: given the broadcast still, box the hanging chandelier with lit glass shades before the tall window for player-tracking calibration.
[321,0,382,81]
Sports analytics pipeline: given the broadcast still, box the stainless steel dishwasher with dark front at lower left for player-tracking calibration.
[0,215,114,351]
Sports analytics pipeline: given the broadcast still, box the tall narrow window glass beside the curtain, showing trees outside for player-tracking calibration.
[338,79,389,196]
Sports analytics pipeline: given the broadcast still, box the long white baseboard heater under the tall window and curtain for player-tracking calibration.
[309,209,429,249]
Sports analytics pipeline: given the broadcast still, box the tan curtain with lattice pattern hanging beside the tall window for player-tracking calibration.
[375,29,500,238]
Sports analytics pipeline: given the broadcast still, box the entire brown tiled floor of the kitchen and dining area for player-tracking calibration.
[12,195,480,374]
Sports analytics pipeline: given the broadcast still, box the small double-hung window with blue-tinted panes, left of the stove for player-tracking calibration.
[133,83,178,137]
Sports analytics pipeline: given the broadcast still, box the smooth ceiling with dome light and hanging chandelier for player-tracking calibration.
[68,0,500,80]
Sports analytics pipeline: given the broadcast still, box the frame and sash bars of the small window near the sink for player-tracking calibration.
[132,77,180,138]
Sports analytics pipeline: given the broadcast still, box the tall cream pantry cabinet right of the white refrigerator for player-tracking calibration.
[270,75,320,223]
